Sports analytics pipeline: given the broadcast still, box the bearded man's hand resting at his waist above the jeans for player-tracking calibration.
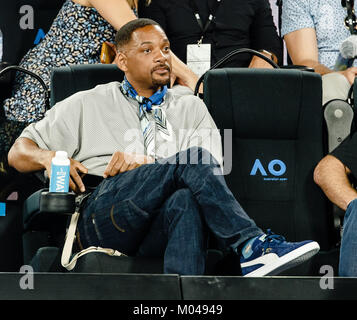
[103,151,155,178]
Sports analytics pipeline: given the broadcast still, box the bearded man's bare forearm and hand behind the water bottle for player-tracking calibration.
[8,138,88,192]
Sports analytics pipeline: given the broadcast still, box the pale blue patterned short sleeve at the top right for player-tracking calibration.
[281,0,315,36]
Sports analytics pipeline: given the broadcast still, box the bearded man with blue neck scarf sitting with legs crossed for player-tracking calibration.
[9,19,319,276]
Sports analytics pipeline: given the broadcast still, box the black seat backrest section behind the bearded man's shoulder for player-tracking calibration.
[50,64,124,106]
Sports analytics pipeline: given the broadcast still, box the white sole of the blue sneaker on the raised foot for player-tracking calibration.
[244,242,320,277]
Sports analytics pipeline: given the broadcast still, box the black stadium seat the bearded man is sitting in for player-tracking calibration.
[27,64,221,274]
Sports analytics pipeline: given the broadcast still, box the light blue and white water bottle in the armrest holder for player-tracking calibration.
[50,151,70,192]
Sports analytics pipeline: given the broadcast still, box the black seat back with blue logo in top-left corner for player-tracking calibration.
[0,0,65,65]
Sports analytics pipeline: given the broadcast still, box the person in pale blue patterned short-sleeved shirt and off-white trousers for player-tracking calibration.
[282,0,357,105]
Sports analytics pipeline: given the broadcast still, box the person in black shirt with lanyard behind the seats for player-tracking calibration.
[139,0,282,75]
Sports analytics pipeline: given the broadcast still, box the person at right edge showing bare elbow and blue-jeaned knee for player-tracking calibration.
[314,132,357,277]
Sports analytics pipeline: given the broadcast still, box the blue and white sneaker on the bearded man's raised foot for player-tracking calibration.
[240,230,320,277]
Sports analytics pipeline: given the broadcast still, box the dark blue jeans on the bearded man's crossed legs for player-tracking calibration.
[78,148,262,275]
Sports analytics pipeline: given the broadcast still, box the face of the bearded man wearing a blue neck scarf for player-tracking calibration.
[116,25,171,91]
